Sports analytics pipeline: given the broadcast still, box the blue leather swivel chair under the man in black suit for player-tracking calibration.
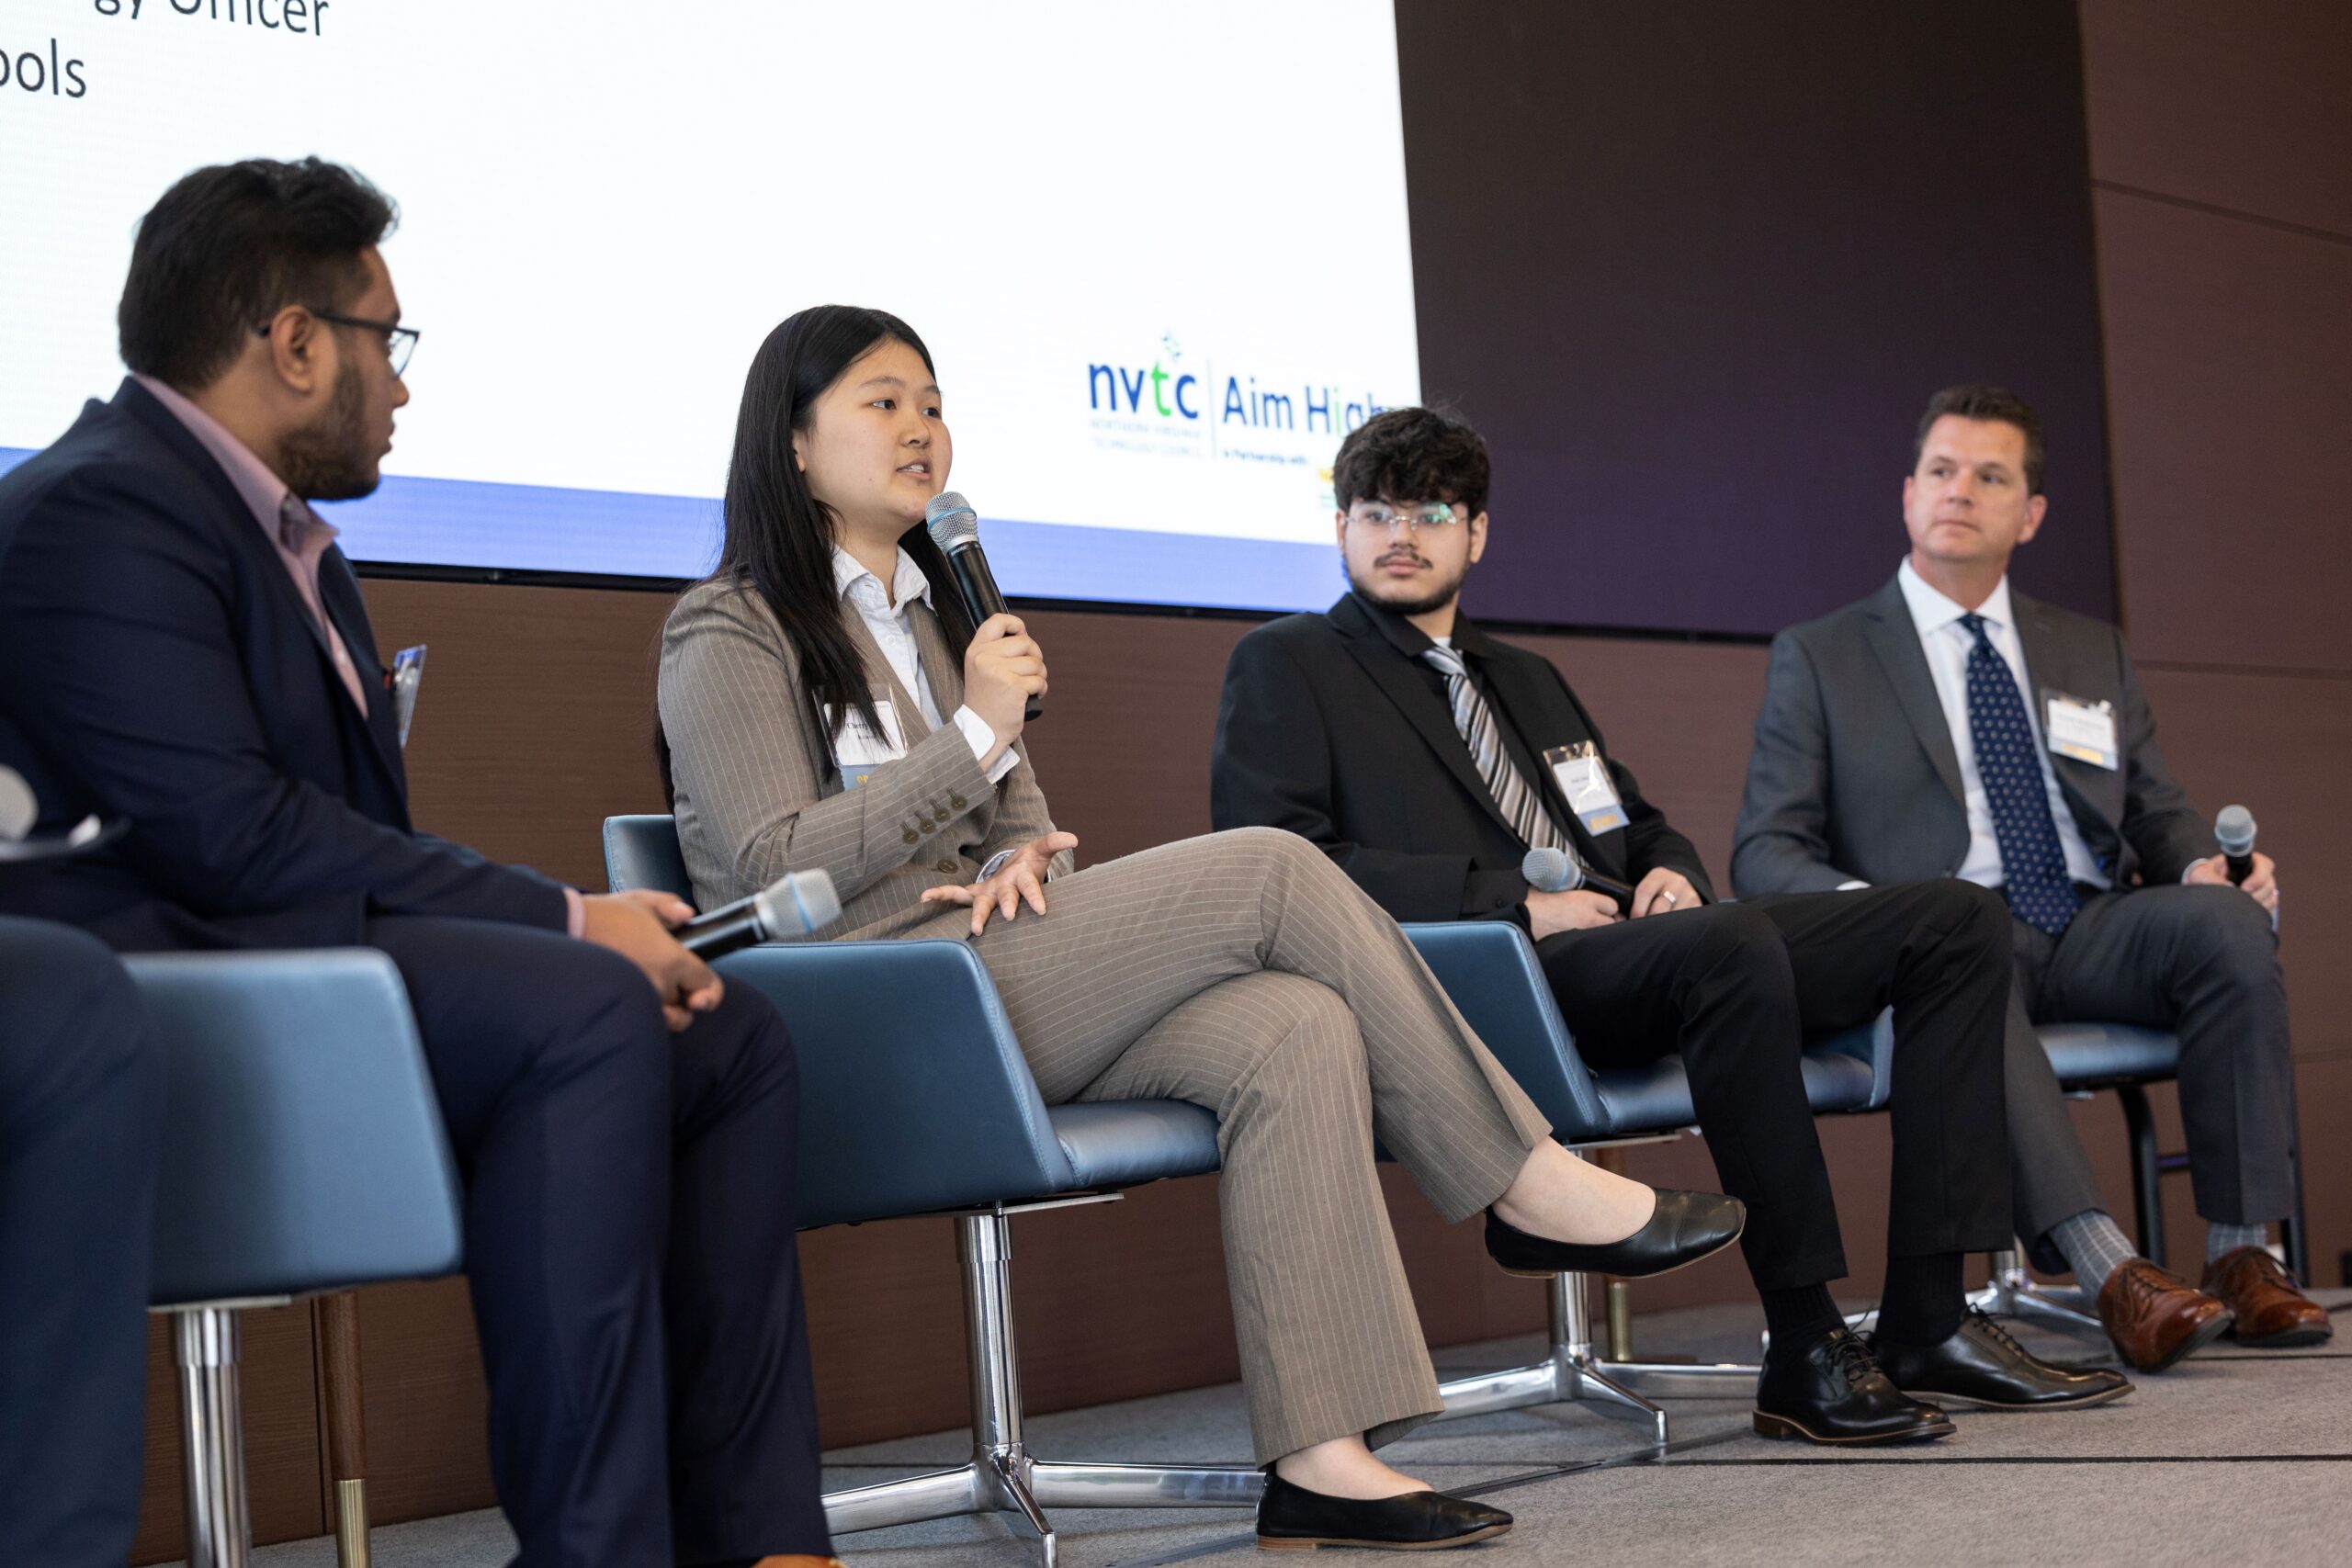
[1404,921,1894,1443]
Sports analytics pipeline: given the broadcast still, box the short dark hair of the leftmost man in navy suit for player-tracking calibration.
[115,157,400,390]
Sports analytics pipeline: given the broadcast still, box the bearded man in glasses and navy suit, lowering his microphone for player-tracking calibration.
[0,160,828,1565]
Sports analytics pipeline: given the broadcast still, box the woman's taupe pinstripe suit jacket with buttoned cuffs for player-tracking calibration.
[661,583,1070,938]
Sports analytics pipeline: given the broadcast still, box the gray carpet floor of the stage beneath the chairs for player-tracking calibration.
[198,1291,2352,1568]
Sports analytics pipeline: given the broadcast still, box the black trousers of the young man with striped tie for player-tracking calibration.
[1536,882,2011,1291]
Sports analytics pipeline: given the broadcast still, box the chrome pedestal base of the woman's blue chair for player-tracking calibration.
[826,1199,1265,1568]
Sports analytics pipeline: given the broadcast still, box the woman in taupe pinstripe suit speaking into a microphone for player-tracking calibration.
[661,306,1740,1544]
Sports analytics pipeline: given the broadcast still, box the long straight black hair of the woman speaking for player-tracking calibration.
[656,306,974,787]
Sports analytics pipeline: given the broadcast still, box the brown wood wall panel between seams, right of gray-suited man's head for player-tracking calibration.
[2098,190,2352,670]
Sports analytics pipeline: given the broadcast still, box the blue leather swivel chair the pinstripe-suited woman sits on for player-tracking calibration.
[605,816,1265,1565]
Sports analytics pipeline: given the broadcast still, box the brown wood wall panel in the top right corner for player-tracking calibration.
[2082,0,2352,235]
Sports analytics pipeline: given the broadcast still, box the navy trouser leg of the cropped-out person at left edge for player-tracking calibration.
[0,917,163,1568]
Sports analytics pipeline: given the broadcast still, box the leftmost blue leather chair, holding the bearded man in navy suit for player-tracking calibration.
[125,950,463,1568]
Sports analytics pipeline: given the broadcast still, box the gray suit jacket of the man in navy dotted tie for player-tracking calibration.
[1731,581,2218,896]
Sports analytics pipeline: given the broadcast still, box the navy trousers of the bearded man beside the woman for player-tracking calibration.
[367,917,831,1568]
